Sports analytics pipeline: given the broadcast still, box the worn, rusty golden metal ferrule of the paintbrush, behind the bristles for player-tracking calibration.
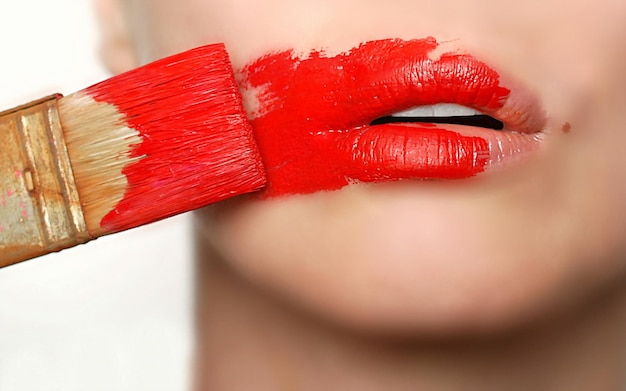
[0,95,92,267]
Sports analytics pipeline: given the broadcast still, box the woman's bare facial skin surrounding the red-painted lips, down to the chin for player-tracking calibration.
[105,0,626,336]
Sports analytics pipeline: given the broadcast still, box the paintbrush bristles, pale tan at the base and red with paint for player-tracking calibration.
[59,44,265,236]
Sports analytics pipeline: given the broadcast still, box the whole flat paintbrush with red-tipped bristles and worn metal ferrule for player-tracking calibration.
[0,44,265,267]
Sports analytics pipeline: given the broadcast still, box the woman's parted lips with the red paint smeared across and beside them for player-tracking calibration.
[240,38,545,196]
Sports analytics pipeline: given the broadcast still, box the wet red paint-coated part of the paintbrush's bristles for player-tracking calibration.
[85,44,265,232]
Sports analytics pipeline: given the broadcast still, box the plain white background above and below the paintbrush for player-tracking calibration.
[0,0,192,391]
